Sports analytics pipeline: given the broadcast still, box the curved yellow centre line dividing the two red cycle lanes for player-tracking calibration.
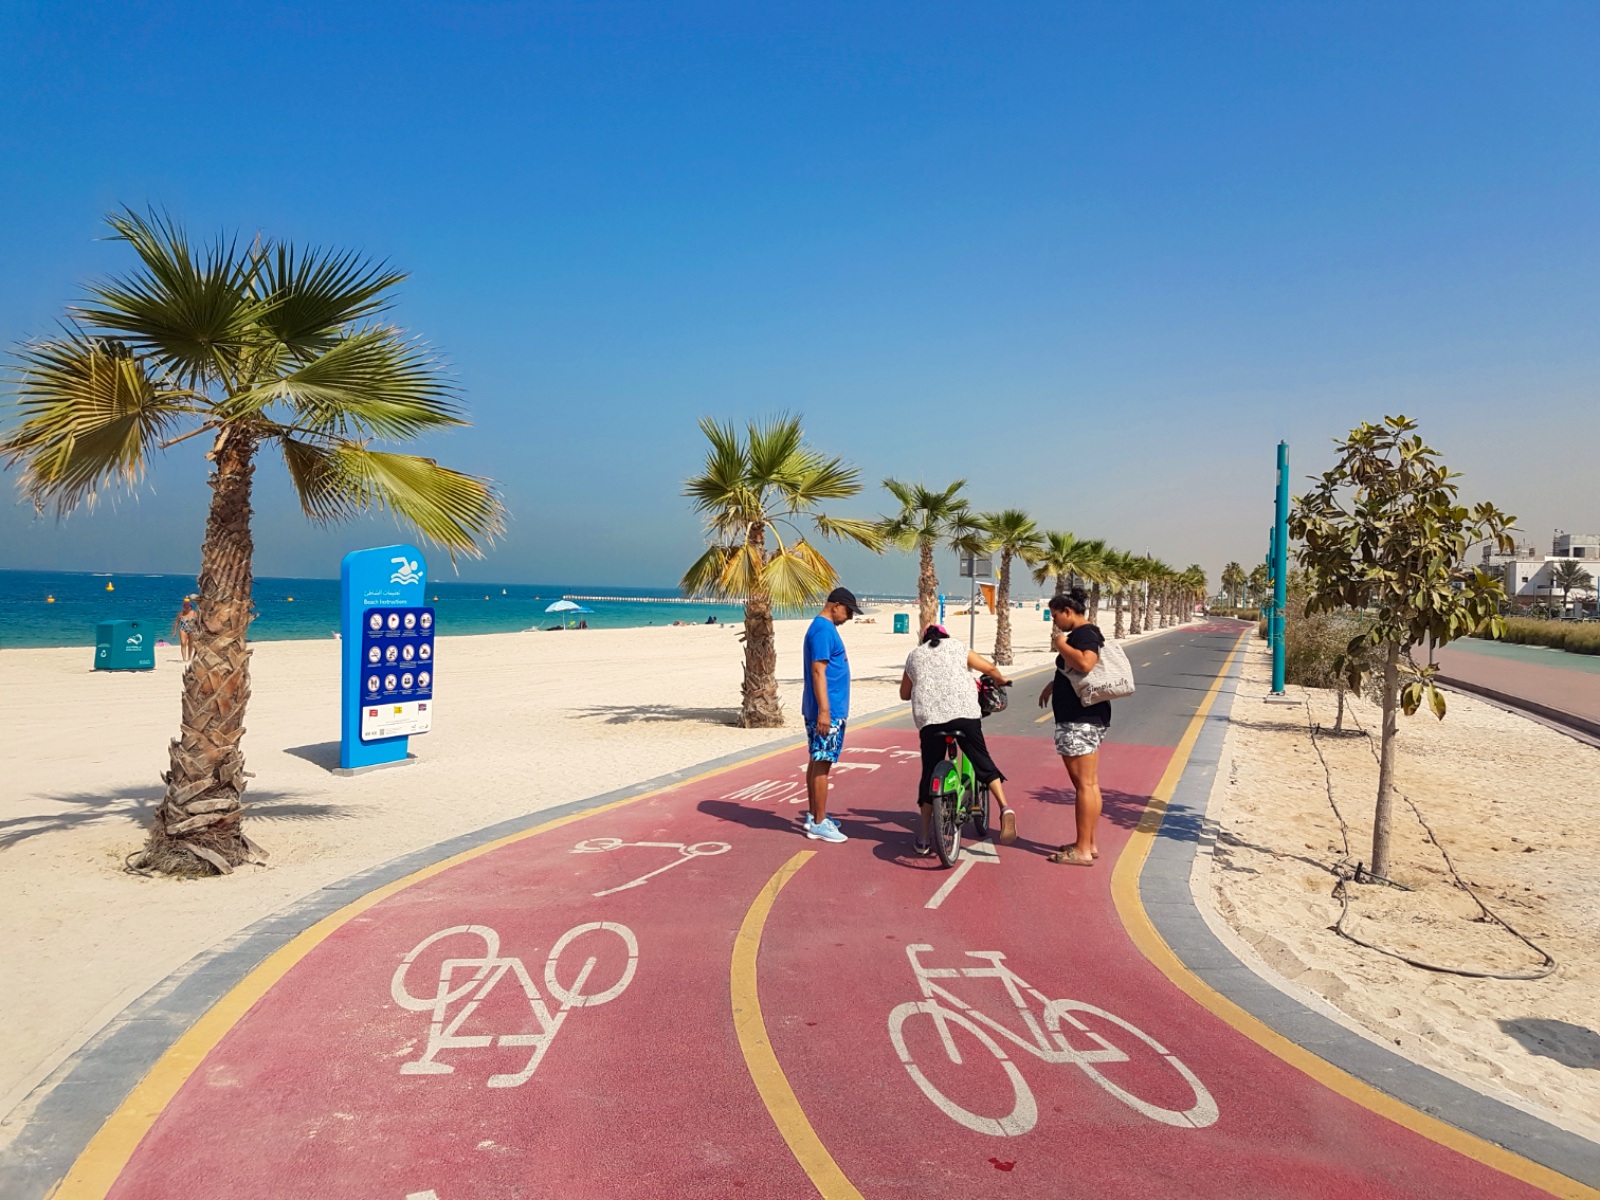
[730,850,862,1200]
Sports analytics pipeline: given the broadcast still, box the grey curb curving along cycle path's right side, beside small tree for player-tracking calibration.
[1139,656,1600,1187]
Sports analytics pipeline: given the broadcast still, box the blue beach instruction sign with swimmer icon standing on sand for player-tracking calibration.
[339,546,435,770]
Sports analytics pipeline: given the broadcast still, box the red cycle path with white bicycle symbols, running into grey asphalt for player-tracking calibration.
[46,627,1578,1200]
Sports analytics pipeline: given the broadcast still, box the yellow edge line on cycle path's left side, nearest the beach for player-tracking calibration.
[51,704,906,1200]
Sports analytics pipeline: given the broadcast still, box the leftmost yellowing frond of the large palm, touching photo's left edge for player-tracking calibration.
[0,333,195,515]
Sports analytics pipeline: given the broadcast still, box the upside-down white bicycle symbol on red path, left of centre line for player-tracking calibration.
[389,922,638,1088]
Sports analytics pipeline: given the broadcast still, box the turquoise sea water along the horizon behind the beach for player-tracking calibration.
[0,571,744,648]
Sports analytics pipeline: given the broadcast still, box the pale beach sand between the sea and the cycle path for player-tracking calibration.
[0,603,1088,1142]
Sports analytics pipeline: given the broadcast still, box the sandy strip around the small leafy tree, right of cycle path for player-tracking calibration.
[1197,642,1600,1139]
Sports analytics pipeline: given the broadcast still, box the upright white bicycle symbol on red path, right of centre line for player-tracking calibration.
[890,946,1218,1138]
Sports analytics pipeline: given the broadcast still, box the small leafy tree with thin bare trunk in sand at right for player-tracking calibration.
[1290,416,1515,877]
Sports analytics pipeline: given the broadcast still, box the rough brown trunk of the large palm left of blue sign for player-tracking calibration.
[138,429,258,875]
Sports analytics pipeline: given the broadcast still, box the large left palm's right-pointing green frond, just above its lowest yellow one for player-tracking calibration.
[219,328,466,442]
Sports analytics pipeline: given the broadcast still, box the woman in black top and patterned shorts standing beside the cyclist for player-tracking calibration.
[1038,587,1110,867]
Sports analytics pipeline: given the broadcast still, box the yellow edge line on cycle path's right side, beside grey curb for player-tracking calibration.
[1110,634,1600,1200]
